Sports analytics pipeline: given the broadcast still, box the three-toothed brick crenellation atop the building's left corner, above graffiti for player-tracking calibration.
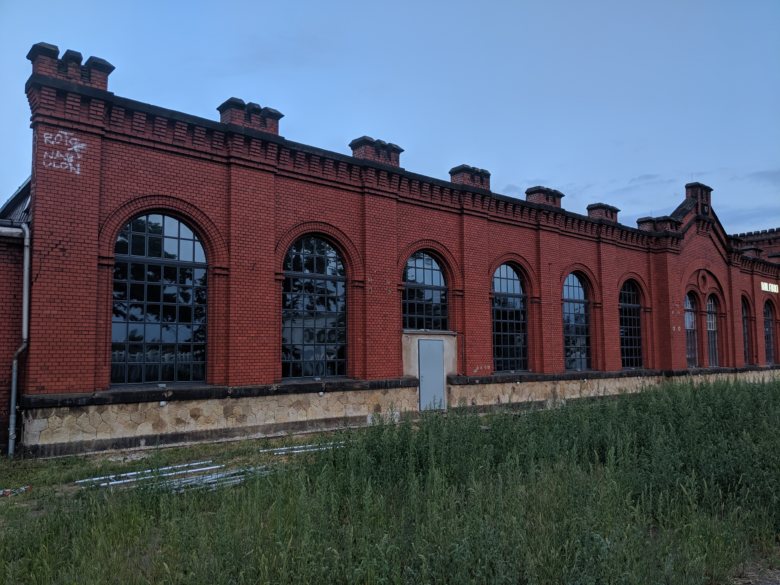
[27,43,114,90]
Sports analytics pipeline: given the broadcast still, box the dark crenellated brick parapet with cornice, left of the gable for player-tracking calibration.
[22,43,688,256]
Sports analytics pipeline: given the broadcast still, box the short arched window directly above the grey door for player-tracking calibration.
[402,252,448,331]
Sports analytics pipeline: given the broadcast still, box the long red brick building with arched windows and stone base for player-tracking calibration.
[0,43,780,452]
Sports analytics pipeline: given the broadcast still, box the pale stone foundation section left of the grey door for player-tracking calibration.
[22,386,418,455]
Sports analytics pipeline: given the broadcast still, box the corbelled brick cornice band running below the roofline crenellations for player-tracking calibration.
[26,74,732,253]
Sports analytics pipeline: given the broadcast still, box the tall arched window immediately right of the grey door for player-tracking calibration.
[493,264,528,372]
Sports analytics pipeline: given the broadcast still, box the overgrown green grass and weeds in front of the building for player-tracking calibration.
[0,384,780,585]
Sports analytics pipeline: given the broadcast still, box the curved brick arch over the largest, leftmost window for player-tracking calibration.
[98,195,228,268]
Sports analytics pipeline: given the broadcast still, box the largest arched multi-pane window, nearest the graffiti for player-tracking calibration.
[111,213,207,384]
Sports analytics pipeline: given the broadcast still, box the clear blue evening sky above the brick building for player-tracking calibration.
[0,0,780,233]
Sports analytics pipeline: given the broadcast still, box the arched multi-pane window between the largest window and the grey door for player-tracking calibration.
[282,235,347,378]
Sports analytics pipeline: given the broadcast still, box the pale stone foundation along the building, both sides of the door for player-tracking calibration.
[22,369,780,455]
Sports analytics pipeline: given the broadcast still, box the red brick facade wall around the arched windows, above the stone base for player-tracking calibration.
[15,41,780,402]
